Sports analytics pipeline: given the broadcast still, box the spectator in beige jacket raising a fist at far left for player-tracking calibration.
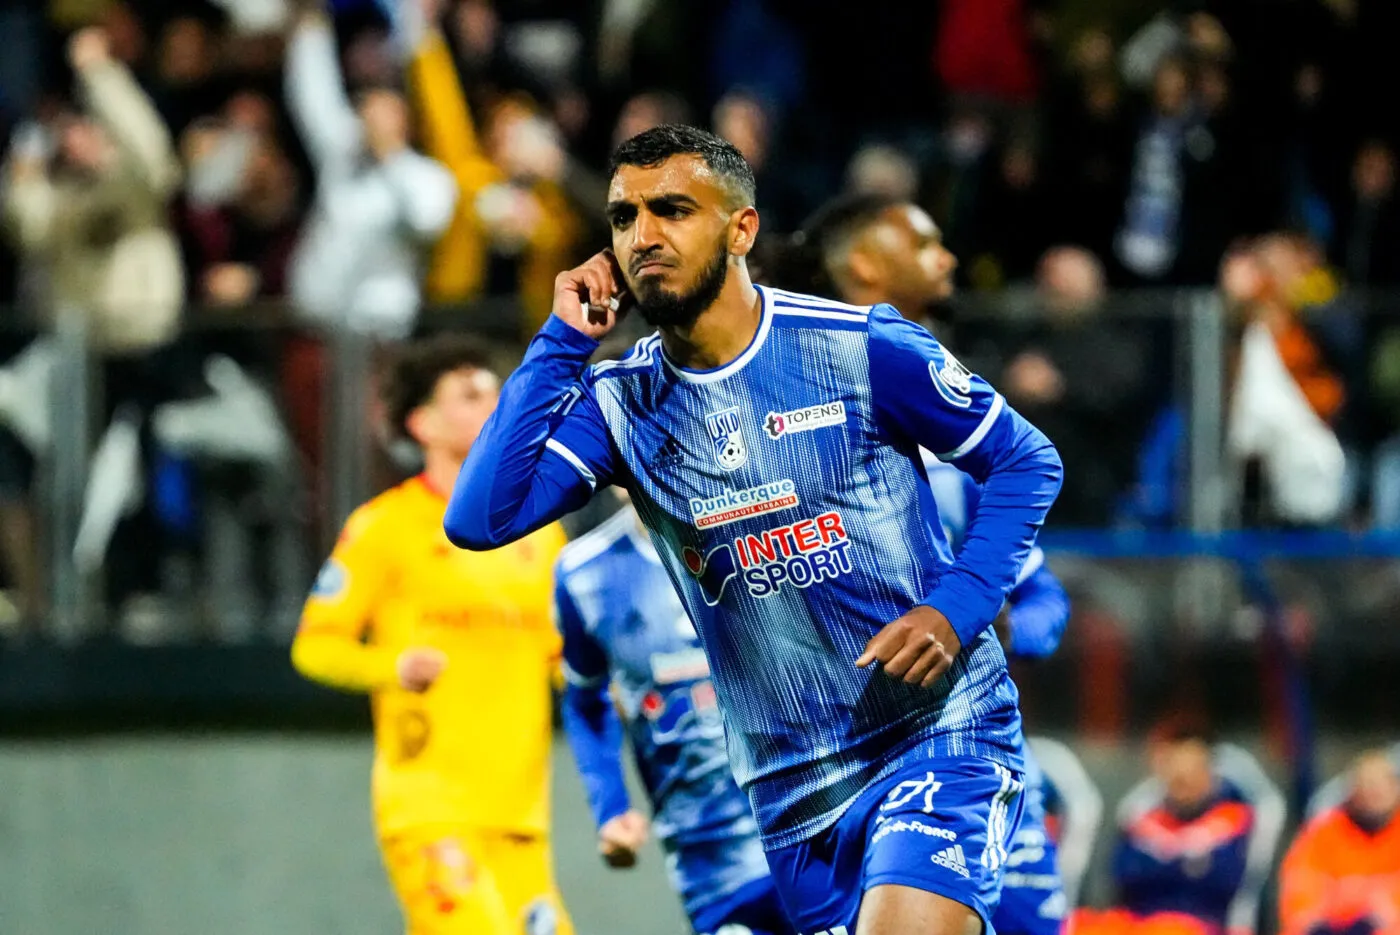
[4,27,183,632]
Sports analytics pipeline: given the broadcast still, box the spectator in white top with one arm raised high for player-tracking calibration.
[286,4,458,337]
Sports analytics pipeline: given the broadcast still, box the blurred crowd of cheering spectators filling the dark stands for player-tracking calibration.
[0,0,1400,635]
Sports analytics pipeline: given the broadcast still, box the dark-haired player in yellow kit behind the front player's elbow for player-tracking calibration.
[291,339,573,935]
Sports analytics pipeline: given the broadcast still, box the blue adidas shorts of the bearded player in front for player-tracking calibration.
[769,757,1025,935]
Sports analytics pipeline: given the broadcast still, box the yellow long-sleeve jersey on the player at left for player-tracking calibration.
[291,477,566,836]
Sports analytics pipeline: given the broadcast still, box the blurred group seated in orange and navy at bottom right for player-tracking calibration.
[1052,726,1400,935]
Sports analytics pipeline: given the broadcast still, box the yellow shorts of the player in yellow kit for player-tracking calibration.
[379,826,574,935]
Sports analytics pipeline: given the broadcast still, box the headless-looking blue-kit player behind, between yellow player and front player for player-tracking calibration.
[554,507,792,935]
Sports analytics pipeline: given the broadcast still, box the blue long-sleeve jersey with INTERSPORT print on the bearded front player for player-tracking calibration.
[445,287,1061,847]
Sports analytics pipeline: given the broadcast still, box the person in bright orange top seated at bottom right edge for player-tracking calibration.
[1278,750,1400,935]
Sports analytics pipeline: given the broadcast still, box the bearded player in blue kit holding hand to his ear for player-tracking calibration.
[445,126,1061,935]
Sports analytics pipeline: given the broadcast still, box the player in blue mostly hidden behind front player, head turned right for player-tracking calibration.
[774,195,1070,935]
